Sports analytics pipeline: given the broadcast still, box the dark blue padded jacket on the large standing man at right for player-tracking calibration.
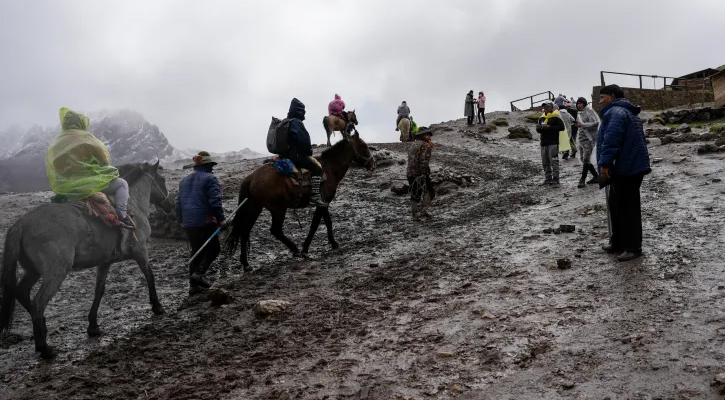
[597,99,652,176]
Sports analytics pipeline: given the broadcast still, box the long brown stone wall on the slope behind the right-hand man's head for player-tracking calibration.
[592,86,715,111]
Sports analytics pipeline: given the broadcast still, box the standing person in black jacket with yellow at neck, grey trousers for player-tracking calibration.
[536,101,566,186]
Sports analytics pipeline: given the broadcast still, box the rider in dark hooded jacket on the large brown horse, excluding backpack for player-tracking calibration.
[280,98,327,207]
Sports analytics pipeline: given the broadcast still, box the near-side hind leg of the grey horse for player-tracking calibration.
[30,263,71,359]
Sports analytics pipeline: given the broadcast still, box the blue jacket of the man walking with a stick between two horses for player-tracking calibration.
[176,164,224,228]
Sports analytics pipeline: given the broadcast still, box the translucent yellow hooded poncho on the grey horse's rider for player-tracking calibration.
[45,107,118,201]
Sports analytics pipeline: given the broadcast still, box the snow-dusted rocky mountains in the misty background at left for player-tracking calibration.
[0,110,263,192]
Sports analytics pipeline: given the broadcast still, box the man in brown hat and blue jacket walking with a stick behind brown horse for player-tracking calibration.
[176,151,226,294]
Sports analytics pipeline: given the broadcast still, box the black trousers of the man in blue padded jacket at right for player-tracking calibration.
[609,174,644,251]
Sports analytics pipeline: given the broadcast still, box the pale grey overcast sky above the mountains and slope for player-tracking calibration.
[0,0,725,151]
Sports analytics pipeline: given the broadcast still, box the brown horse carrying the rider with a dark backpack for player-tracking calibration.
[225,131,375,270]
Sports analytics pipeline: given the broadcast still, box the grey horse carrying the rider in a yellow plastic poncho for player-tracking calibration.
[0,162,171,358]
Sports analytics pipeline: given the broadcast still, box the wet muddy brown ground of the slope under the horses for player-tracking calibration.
[0,113,725,399]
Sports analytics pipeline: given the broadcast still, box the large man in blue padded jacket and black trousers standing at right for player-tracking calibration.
[597,85,652,261]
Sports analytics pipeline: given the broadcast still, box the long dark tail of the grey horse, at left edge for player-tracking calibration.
[0,222,23,334]
